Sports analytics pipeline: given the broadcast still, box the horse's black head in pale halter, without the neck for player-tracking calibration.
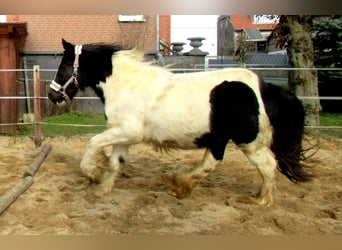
[48,39,82,104]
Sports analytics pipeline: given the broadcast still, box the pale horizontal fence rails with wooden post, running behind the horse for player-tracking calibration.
[0,65,342,145]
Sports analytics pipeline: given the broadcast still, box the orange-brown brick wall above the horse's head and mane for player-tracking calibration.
[14,15,156,51]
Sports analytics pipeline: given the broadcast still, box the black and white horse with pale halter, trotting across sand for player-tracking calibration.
[48,39,312,206]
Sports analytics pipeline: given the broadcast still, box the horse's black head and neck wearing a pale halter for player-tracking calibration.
[48,39,123,104]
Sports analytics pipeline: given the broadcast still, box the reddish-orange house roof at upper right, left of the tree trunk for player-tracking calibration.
[229,15,277,31]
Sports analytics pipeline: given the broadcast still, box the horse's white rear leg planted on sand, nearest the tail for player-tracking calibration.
[238,142,277,206]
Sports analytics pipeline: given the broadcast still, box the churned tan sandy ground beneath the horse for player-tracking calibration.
[0,137,342,235]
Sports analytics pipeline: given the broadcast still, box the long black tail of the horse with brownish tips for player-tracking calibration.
[261,83,313,183]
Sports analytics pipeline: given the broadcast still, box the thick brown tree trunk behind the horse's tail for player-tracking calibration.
[280,15,321,129]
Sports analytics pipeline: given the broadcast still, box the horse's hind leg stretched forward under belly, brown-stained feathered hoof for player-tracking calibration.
[162,149,221,199]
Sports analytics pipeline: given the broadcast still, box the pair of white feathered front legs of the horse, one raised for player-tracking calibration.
[80,128,141,195]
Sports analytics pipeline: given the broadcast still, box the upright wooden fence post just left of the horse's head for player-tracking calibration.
[33,65,42,148]
